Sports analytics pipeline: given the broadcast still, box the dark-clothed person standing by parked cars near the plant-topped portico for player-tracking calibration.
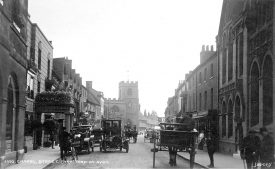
[59,127,70,160]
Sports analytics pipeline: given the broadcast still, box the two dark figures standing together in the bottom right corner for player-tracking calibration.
[240,127,274,169]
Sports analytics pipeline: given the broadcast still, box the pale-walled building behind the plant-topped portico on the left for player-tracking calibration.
[25,18,53,149]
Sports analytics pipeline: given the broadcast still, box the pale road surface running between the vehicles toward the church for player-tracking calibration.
[47,135,203,169]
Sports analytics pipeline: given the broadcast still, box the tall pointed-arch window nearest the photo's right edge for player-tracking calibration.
[263,56,273,126]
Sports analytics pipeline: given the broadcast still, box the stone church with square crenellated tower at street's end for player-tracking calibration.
[104,81,140,128]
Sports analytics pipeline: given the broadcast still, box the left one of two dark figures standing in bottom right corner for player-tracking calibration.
[240,129,261,169]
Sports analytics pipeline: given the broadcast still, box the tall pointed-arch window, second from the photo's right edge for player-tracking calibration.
[250,62,260,127]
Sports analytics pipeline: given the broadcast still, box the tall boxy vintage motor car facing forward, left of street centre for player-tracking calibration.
[100,120,129,153]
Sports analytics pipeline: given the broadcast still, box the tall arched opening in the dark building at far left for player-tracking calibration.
[6,76,16,152]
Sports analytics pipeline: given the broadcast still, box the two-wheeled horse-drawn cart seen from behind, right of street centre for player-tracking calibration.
[151,123,198,168]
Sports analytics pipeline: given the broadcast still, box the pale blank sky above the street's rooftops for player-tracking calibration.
[29,0,222,116]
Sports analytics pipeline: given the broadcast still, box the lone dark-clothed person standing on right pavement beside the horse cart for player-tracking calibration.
[206,132,217,168]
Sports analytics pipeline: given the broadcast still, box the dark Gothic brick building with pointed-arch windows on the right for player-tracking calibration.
[217,0,275,153]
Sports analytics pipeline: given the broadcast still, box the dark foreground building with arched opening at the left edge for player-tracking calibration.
[0,0,28,168]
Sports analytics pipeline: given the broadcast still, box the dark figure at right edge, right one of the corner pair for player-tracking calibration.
[260,127,274,168]
